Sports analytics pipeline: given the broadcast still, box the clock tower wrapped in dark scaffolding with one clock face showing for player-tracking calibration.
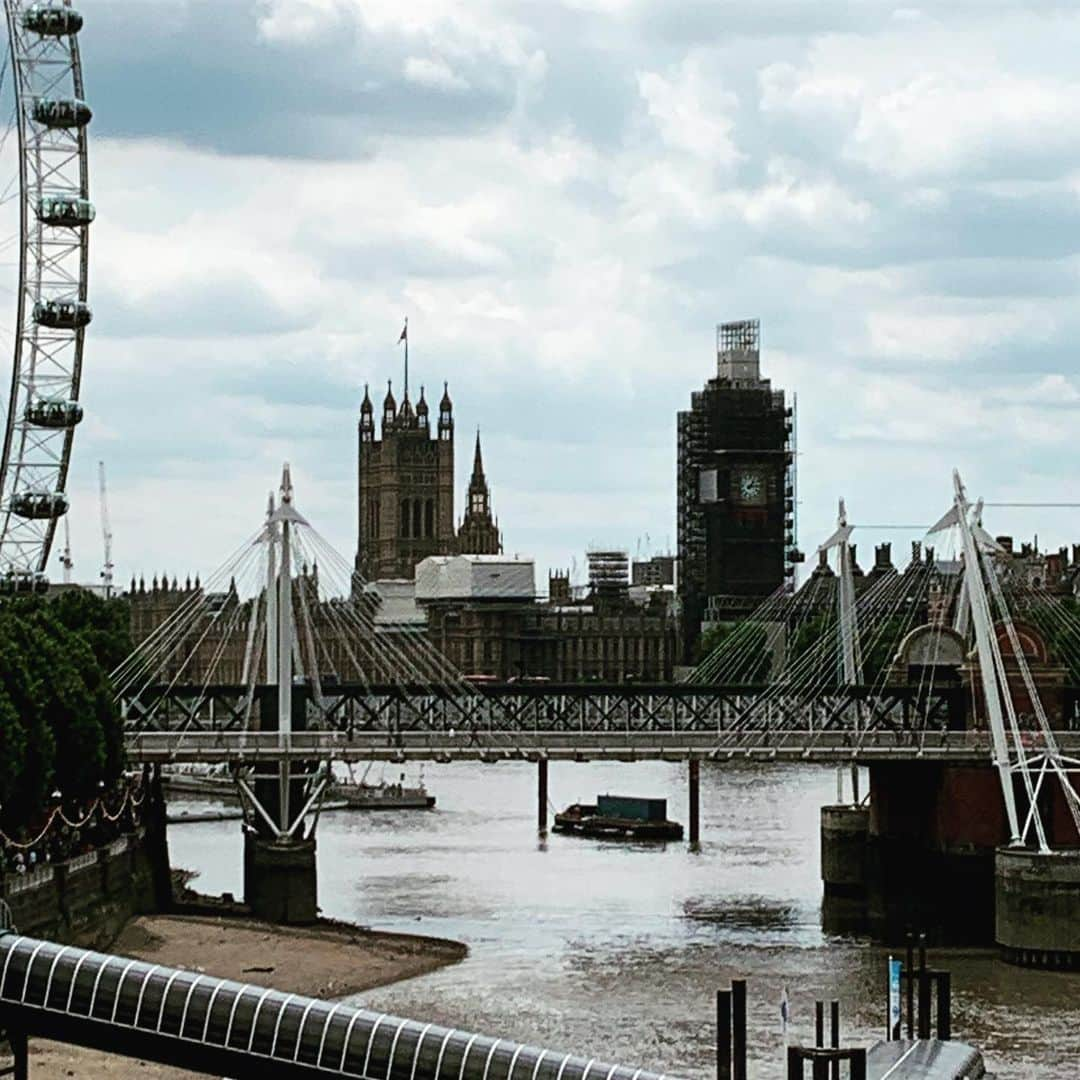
[678,320,800,662]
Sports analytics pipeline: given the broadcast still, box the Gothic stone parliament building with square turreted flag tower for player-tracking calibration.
[129,371,676,683]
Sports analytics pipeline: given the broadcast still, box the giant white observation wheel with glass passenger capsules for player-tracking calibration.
[0,0,94,593]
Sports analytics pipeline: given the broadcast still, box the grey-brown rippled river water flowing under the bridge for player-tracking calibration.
[170,761,1080,1080]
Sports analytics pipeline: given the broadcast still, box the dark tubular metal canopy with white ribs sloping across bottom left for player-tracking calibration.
[0,933,664,1080]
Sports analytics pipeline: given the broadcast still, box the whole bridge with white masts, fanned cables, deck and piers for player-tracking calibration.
[113,465,1080,963]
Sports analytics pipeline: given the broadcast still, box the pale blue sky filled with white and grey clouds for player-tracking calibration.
[39,0,1080,581]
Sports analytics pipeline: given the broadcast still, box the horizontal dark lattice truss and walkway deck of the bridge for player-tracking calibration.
[124,683,1080,765]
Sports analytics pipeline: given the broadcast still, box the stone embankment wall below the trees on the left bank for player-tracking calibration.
[0,828,160,948]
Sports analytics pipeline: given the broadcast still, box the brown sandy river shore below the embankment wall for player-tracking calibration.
[21,915,465,1080]
